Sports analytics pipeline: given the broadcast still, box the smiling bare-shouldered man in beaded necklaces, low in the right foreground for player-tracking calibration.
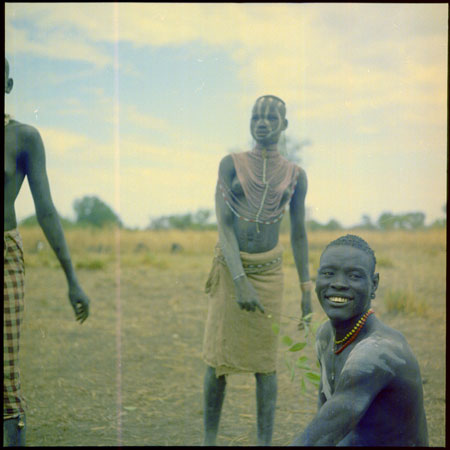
[292,235,428,447]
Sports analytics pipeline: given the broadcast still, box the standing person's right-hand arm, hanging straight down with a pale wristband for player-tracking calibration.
[289,169,312,326]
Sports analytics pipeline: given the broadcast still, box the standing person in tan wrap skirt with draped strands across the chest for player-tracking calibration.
[203,95,312,445]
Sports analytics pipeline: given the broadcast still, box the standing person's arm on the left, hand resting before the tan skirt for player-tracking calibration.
[215,155,264,312]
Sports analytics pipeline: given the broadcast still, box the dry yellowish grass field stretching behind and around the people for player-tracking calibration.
[15,228,446,446]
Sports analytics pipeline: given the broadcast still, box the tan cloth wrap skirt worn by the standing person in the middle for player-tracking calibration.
[203,244,284,376]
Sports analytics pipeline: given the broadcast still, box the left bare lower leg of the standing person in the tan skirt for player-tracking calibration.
[203,366,227,446]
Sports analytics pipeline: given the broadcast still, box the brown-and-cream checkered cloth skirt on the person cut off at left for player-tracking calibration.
[3,229,25,420]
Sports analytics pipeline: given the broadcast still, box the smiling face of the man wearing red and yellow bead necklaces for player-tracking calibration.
[316,245,379,322]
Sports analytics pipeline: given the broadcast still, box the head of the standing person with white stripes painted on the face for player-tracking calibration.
[250,96,288,145]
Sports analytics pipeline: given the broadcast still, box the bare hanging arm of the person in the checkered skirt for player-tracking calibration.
[21,126,89,323]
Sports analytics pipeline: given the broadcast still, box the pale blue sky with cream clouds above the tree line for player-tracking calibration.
[5,3,448,228]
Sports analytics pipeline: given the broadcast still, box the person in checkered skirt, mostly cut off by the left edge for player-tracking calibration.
[3,58,89,447]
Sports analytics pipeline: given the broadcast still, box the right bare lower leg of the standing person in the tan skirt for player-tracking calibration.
[255,373,277,446]
